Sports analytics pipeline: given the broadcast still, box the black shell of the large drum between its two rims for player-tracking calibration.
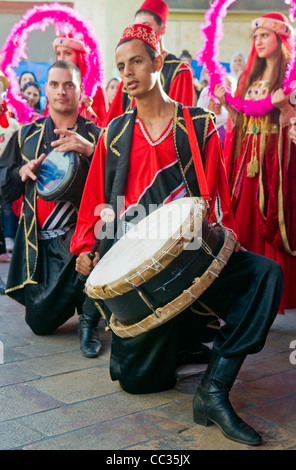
[104,219,224,325]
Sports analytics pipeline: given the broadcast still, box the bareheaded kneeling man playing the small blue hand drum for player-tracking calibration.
[0,61,101,357]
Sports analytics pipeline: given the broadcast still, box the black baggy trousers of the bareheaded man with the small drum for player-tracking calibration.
[24,231,99,335]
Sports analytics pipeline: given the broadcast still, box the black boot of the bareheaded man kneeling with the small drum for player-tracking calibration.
[78,302,102,358]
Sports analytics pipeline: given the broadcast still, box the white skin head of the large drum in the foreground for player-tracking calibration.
[86,197,205,290]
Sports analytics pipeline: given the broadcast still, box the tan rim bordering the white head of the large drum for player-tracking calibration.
[85,197,207,300]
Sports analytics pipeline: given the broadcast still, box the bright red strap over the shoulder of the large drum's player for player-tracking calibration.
[183,106,211,205]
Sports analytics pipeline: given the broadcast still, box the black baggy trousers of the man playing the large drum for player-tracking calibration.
[110,251,283,393]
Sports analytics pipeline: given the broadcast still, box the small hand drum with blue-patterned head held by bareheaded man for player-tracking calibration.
[37,151,89,207]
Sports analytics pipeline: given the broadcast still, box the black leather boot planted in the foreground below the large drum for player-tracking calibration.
[193,353,262,446]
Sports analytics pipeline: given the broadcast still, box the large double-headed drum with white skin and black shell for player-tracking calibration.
[85,198,236,337]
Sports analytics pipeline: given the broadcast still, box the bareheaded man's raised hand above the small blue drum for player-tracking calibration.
[51,129,95,157]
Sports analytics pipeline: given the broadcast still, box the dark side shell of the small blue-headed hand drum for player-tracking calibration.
[37,152,89,207]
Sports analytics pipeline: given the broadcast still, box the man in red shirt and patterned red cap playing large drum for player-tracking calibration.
[71,25,282,445]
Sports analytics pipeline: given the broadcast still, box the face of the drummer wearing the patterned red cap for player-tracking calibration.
[116,39,157,98]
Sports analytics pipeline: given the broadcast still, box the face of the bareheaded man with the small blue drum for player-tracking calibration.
[45,68,82,114]
